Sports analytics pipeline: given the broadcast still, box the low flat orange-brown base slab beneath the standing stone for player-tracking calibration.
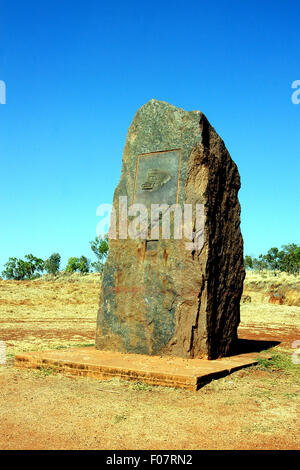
[15,347,268,390]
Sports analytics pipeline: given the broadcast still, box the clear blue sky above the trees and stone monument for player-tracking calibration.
[0,0,300,271]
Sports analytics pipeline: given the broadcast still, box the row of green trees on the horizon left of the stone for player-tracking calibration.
[2,235,108,281]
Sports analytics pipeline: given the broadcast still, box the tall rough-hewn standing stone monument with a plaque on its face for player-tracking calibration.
[96,99,245,359]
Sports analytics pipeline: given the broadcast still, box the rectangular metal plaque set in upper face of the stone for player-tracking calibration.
[133,150,180,207]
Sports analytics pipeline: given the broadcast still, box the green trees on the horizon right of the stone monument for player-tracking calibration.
[244,243,300,274]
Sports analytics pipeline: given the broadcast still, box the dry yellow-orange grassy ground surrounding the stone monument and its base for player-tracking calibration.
[0,274,300,450]
